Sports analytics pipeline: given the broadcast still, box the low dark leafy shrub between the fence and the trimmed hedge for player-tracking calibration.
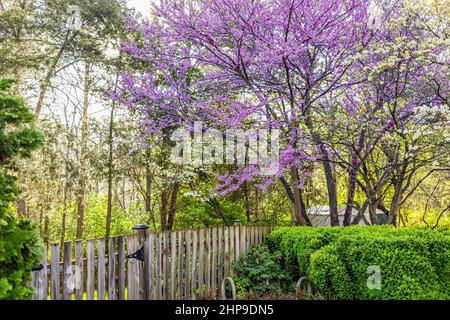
[234,244,290,297]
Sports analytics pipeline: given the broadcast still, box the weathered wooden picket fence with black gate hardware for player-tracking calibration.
[31,225,271,300]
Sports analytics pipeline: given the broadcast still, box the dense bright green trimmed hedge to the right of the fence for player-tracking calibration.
[268,226,450,299]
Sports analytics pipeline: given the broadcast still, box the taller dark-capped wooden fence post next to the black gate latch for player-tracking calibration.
[133,224,150,300]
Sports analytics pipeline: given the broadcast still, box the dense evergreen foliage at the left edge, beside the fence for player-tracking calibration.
[0,80,42,299]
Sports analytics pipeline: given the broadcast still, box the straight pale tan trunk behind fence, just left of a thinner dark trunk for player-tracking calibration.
[76,61,92,238]
